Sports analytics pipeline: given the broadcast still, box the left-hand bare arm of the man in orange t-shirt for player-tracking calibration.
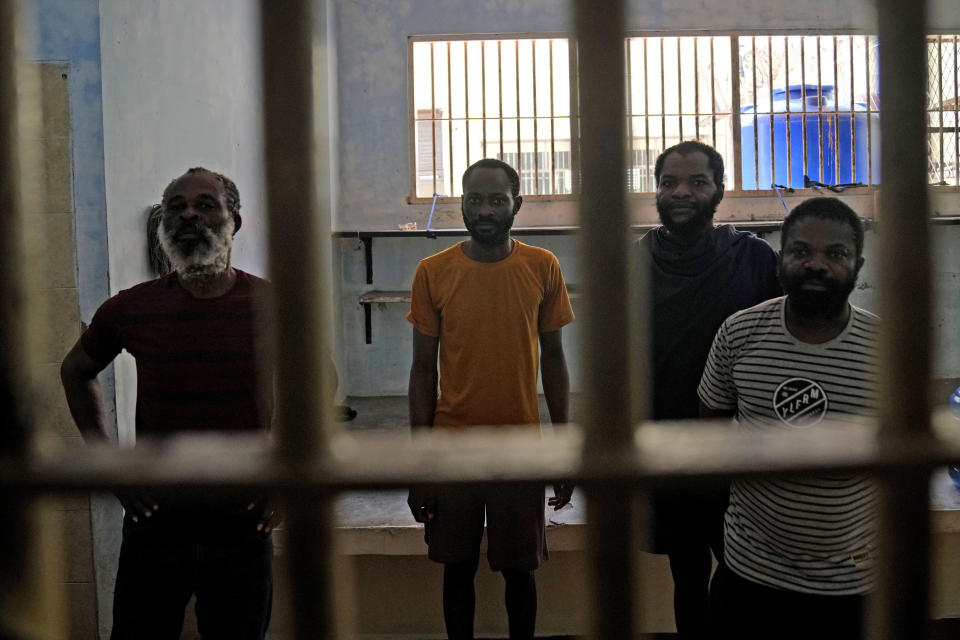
[407,327,440,523]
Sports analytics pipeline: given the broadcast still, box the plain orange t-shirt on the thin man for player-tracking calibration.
[407,240,573,426]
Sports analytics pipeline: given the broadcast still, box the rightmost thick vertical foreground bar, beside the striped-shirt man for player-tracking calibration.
[868,0,931,640]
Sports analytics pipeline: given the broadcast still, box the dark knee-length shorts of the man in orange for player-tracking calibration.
[424,485,547,571]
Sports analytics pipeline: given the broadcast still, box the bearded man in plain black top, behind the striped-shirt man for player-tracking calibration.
[639,141,780,640]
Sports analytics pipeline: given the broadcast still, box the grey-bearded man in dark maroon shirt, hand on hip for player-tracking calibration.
[61,168,278,640]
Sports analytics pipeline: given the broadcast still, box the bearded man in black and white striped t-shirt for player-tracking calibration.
[699,198,878,640]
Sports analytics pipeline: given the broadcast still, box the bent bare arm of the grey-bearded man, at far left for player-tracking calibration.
[60,340,110,442]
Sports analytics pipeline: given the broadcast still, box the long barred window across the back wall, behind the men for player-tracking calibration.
[411,32,960,199]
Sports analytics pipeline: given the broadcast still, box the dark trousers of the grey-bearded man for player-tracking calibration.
[111,511,273,640]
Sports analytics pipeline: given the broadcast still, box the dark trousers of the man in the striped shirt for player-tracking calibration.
[710,564,865,640]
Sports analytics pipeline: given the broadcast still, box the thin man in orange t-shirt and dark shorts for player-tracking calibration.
[407,159,573,640]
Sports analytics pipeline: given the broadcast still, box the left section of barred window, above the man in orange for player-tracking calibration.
[410,37,573,198]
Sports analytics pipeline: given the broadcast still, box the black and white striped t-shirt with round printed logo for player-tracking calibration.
[699,297,879,595]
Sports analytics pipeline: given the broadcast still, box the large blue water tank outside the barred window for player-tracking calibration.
[740,84,880,189]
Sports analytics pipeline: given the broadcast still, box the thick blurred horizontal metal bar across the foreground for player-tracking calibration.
[9,412,960,492]
